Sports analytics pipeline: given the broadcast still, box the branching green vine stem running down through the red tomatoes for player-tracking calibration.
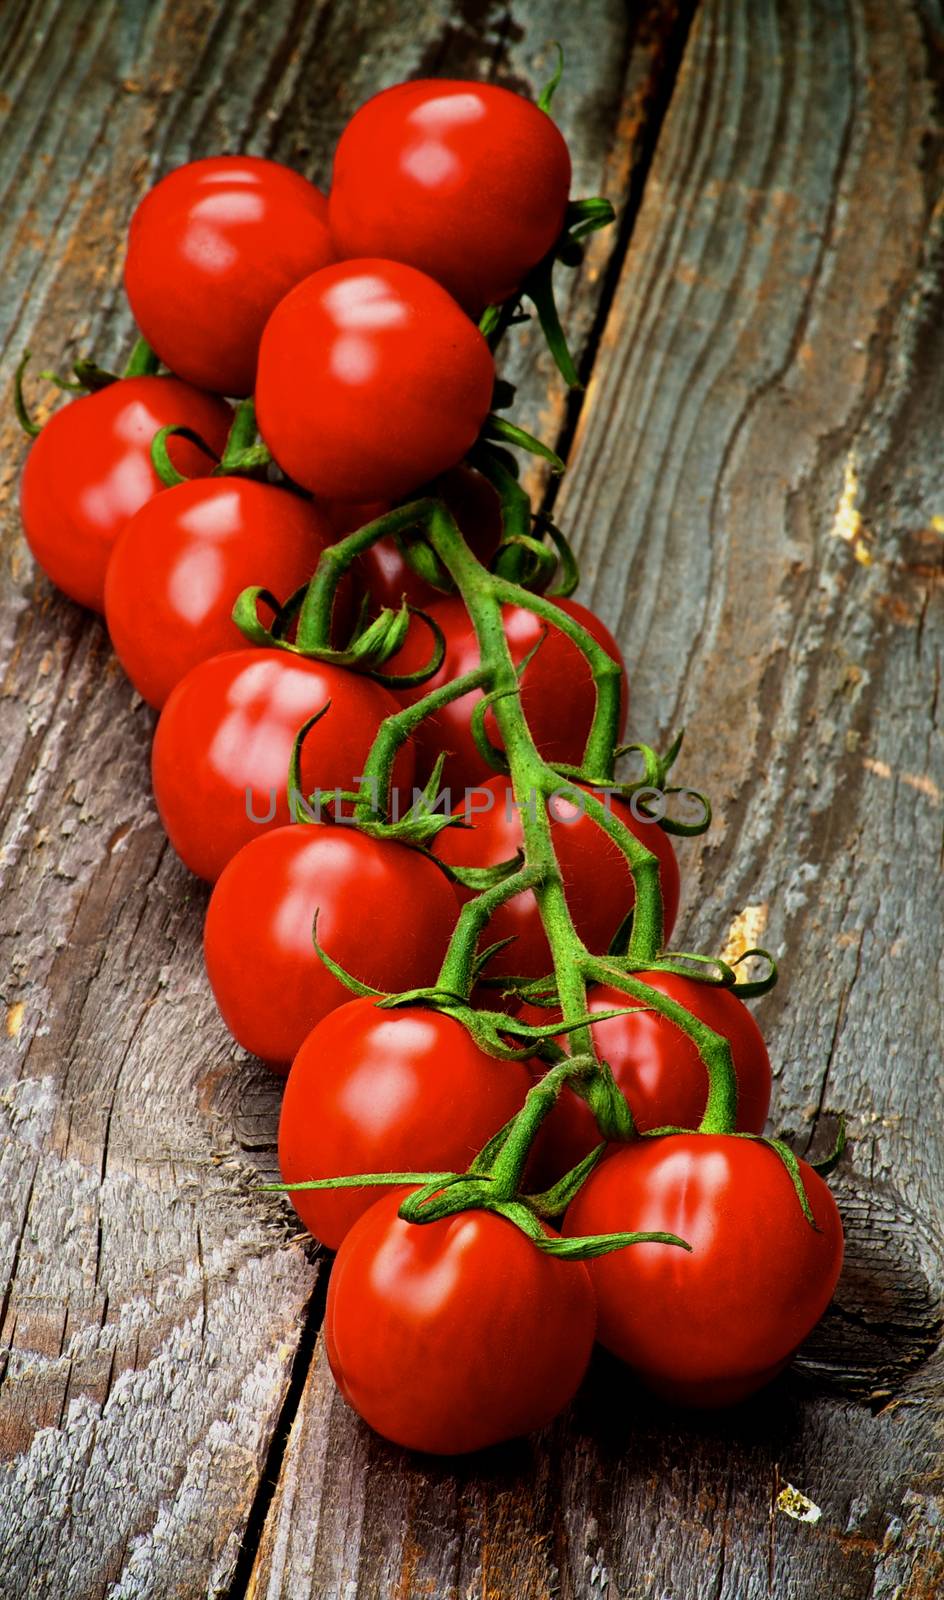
[256,498,752,1228]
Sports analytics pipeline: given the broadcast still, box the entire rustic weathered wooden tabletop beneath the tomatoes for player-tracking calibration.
[0,0,944,1600]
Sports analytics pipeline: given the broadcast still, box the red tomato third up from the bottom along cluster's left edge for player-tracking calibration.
[203,822,458,1062]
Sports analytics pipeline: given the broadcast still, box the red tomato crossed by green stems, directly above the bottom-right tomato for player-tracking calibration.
[521,952,771,1184]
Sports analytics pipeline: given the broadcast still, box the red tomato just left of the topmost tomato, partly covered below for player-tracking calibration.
[125,155,334,395]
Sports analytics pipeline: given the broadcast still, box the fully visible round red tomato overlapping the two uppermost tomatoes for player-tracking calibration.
[256,261,494,501]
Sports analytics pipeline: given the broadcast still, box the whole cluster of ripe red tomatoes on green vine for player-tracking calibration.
[16,62,842,1453]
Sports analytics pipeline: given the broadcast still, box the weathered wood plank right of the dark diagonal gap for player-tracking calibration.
[250,0,944,1600]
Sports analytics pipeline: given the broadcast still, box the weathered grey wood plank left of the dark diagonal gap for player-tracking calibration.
[0,0,675,1600]
